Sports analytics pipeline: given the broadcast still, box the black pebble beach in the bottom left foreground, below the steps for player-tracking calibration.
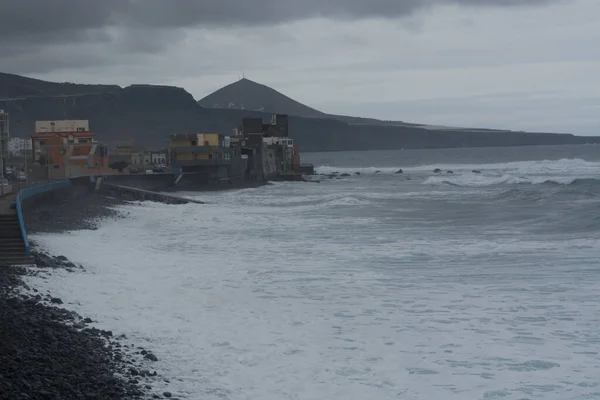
[0,266,149,400]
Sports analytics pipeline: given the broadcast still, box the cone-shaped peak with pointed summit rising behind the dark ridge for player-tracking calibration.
[198,78,325,117]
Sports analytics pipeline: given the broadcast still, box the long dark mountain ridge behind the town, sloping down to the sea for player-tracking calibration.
[0,74,600,152]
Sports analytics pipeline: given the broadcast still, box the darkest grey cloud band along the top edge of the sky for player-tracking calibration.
[0,0,559,42]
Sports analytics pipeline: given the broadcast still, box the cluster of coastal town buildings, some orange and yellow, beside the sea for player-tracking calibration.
[0,110,314,192]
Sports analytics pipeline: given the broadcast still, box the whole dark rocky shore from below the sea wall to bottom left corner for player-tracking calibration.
[0,195,172,400]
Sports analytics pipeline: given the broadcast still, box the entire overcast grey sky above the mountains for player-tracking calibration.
[0,0,600,135]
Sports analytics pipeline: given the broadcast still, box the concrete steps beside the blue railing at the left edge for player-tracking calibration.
[0,213,34,267]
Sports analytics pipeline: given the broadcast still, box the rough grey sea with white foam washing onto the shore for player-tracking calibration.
[28,145,600,400]
